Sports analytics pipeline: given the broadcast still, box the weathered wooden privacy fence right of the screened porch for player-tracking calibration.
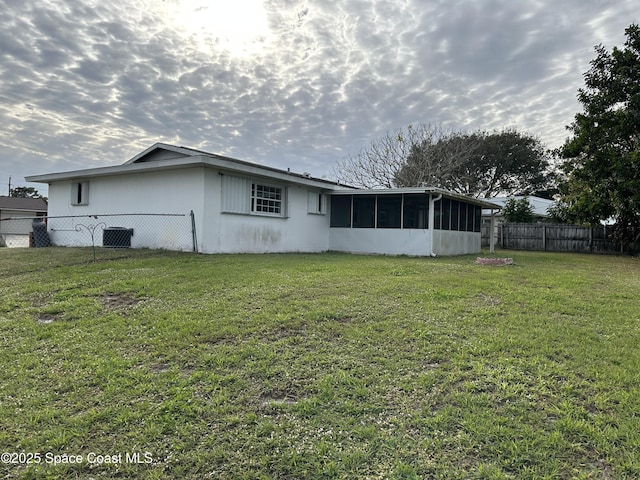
[487,223,623,253]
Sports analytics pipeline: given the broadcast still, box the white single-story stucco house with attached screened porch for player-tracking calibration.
[26,143,498,256]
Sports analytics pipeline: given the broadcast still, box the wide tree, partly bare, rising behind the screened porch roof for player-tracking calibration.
[335,124,552,197]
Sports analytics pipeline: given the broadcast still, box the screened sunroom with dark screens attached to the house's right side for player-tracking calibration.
[329,188,498,256]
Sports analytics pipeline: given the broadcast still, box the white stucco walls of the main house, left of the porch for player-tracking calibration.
[49,167,329,253]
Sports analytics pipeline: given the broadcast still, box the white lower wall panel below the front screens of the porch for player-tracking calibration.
[329,228,431,256]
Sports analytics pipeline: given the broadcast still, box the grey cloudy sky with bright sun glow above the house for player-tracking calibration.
[0,0,640,195]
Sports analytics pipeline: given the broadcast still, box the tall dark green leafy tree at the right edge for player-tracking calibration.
[560,24,640,245]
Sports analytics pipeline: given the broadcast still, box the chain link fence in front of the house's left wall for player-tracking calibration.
[0,212,198,252]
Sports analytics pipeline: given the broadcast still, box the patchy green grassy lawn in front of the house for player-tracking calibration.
[0,249,640,479]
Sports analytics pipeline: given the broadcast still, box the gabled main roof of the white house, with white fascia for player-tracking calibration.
[25,143,356,189]
